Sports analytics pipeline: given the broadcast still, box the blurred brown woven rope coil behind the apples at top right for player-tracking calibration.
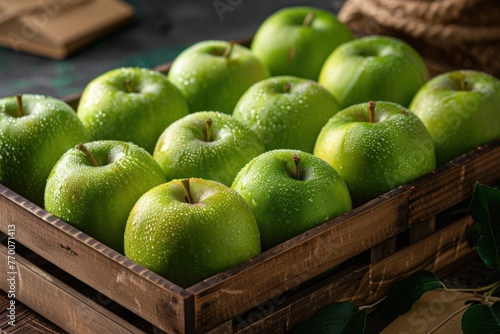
[338,0,500,76]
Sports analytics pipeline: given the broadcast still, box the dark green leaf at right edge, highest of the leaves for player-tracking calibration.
[470,182,500,268]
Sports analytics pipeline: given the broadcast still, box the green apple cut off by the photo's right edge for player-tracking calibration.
[410,70,500,165]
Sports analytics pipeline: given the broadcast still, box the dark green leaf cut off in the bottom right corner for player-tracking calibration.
[462,302,500,334]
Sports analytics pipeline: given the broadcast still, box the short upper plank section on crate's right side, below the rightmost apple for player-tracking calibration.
[409,140,500,226]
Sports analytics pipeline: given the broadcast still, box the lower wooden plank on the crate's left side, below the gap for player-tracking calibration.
[0,245,144,334]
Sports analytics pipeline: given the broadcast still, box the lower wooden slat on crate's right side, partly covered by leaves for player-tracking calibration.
[229,217,474,334]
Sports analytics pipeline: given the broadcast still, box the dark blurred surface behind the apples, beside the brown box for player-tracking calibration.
[0,0,344,98]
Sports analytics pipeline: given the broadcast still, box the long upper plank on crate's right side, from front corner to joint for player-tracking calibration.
[187,187,409,332]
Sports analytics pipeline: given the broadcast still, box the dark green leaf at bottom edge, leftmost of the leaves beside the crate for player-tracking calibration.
[290,302,366,334]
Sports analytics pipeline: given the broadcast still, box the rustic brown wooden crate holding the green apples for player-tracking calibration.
[0,136,500,333]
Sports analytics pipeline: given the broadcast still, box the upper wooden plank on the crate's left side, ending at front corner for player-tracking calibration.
[0,185,193,333]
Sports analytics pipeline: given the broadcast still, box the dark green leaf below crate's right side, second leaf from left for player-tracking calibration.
[380,270,442,318]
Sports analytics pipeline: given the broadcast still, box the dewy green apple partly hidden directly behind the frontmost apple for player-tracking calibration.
[153,111,265,186]
